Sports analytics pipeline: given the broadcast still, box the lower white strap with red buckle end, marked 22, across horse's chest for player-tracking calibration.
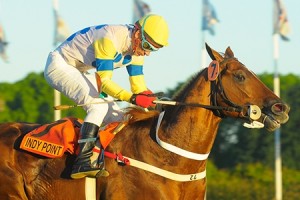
[105,151,206,182]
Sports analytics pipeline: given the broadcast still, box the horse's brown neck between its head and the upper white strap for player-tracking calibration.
[159,78,221,154]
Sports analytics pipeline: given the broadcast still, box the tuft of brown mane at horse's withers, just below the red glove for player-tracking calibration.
[125,107,159,124]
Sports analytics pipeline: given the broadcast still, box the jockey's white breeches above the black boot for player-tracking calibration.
[44,51,123,126]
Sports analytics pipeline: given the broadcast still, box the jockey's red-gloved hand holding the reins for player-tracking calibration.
[130,90,156,108]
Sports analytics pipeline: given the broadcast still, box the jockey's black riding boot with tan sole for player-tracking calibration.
[71,122,109,179]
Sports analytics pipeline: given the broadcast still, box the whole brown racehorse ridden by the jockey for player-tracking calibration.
[0,46,289,200]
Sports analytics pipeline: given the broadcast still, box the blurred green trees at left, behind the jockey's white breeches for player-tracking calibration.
[0,73,85,123]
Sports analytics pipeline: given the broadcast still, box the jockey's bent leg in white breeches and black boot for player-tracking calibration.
[44,54,108,178]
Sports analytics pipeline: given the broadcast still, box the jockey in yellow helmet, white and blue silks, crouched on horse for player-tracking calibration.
[44,14,169,179]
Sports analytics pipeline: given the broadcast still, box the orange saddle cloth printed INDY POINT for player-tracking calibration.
[20,117,120,158]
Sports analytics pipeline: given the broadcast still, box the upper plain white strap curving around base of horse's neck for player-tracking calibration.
[156,112,209,160]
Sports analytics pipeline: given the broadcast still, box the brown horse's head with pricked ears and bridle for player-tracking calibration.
[206,44,290,131]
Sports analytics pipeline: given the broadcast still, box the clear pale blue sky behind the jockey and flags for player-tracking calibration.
[0,0,300,92]
